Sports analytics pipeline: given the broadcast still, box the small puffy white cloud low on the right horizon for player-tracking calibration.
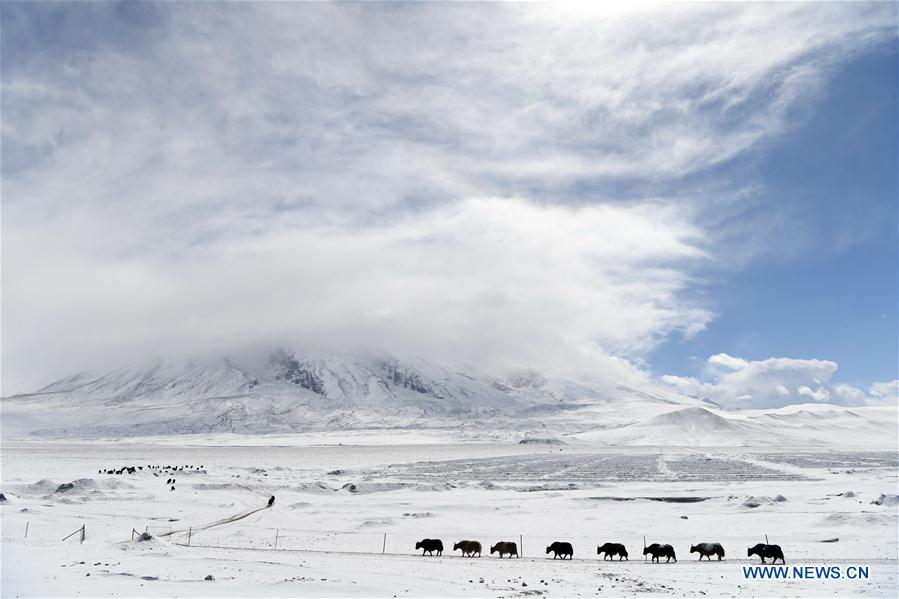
[661,354,896,408]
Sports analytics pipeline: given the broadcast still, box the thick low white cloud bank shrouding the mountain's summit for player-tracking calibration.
[4,198,711,394]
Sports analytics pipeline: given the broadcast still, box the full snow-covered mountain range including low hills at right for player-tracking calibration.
[0,349,894,445]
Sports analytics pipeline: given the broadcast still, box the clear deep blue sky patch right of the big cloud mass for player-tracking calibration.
[651,44,899,384]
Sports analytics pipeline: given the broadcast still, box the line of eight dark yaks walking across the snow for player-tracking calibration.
[415,539,785,564]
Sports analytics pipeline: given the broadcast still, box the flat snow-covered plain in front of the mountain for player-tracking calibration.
[0,436,899,597]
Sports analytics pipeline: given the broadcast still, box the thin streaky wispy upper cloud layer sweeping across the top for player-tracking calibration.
[2,3,893,220]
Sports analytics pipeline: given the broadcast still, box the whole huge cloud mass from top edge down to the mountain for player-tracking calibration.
[0,3,894,393]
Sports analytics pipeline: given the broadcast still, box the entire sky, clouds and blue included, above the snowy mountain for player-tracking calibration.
[0,2,899,407]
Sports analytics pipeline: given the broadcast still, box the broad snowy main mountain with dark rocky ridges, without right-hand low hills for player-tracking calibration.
[2,350,696,436]
